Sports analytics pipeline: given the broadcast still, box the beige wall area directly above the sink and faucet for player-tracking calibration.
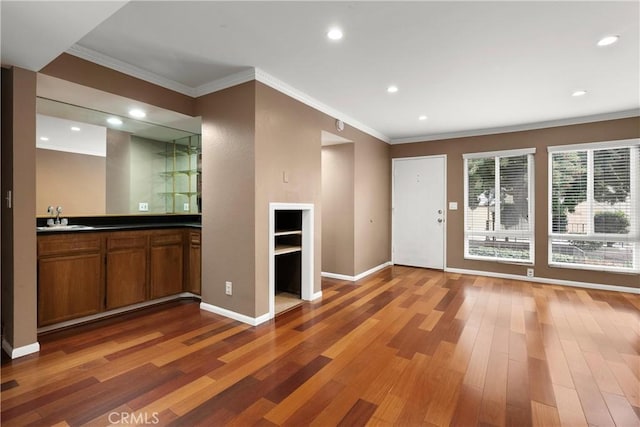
[36,148,106,216]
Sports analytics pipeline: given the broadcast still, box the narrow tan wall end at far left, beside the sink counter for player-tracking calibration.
[2,67,37,348]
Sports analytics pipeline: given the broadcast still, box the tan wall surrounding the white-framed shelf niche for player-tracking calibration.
[255,83,322,315]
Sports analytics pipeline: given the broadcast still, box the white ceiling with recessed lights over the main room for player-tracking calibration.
[1,1,640,142]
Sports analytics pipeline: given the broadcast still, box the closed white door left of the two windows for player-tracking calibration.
[392,156,446,270]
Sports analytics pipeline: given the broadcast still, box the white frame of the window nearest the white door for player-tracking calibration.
[462,148,536,265]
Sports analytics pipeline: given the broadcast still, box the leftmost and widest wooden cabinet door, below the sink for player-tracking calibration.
[38,253,104,326]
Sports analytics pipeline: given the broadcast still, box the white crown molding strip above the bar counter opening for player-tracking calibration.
[66,44,196,98]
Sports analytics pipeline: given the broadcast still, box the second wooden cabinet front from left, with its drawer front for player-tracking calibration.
[106,232,148,309]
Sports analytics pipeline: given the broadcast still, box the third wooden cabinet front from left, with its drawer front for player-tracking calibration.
[150,230,184,298]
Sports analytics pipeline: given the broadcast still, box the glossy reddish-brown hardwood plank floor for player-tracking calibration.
[1,266,640,427]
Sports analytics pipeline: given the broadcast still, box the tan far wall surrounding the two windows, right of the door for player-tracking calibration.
[391,117,640,288]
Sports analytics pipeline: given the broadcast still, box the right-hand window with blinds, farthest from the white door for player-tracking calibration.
[549,140,640,272]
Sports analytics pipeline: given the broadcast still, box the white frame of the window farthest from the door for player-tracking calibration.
[547,138,640,273]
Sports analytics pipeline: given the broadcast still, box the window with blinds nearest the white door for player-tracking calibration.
[463,149,535,263]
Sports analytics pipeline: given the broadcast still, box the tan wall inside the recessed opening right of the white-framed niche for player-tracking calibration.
[322,143,355,276]
